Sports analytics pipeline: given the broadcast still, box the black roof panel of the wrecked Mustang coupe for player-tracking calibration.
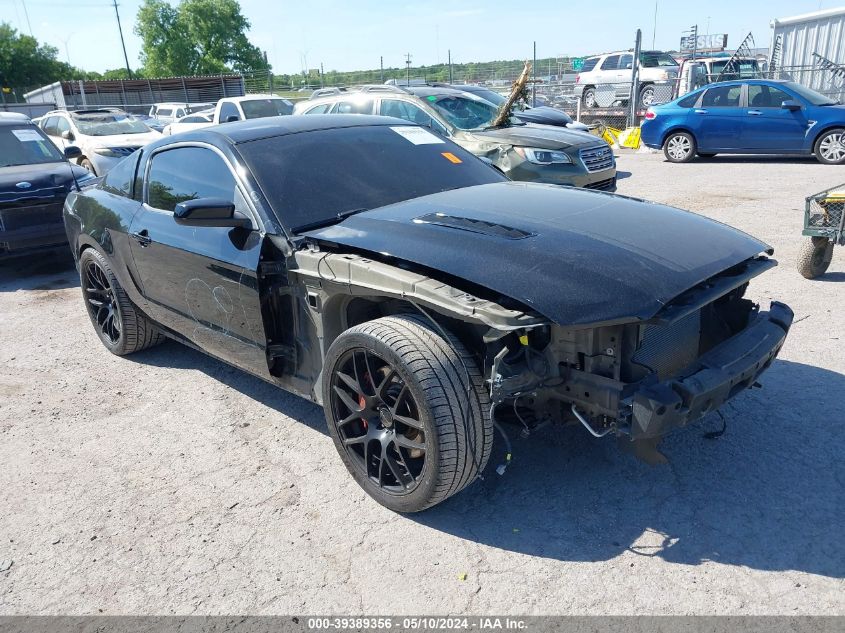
[151,114,414,147]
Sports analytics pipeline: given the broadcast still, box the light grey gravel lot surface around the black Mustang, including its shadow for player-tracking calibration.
[0,153,845,614]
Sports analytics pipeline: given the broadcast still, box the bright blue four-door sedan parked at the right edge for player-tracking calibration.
[641,79,845,165]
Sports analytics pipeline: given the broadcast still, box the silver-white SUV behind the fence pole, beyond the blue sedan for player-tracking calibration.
[575,51,679,108]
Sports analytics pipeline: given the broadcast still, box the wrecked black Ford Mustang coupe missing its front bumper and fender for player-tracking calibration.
[65,115,792,511]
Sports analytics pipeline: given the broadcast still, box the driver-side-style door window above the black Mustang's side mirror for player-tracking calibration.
[147,147,237,211]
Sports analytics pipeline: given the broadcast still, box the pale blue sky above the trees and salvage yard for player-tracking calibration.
[0,0,843,73]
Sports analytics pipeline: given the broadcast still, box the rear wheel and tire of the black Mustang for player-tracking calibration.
[79,248,164,356]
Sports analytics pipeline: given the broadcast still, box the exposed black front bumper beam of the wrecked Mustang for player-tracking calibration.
[631,301,793,440]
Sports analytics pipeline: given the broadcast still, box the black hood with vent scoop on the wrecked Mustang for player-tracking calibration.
[305,182,771,326]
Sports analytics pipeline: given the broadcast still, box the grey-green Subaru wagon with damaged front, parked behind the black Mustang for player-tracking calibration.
[294,85,616,191]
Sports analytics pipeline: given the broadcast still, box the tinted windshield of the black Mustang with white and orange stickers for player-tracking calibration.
[238,125,506,233]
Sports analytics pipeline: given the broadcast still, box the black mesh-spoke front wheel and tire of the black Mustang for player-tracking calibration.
[322,316,493,512]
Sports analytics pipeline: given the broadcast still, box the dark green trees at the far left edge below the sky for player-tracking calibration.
[0,22,67,88]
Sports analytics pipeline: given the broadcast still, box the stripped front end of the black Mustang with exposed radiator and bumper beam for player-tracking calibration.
[488,257,793,445]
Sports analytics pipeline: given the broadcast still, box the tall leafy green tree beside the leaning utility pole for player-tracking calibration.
[135,0,269,77]
